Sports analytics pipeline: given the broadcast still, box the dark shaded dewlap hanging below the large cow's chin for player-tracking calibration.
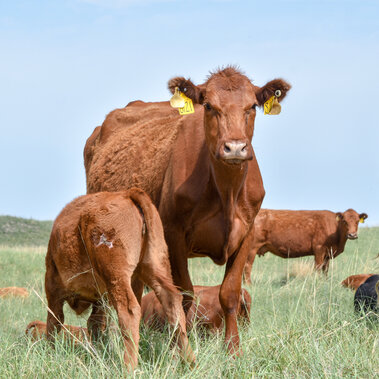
[211,157,248,259]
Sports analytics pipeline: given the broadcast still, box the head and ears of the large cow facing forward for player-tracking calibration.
[168,67,291,165]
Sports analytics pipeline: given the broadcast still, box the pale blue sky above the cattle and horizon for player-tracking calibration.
[0,0,379,225]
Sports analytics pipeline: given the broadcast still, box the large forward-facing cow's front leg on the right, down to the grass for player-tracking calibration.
[219,233,253,355]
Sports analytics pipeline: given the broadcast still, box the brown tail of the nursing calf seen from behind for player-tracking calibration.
[127,187,176,291]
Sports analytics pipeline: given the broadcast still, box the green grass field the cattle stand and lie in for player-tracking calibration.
[0,228,379,378]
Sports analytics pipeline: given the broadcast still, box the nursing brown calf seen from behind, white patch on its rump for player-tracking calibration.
[45,188,194,368]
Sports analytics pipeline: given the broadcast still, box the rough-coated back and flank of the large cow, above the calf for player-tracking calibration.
[84,101,181,203]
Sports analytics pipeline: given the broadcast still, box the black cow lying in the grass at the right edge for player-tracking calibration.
[354,275,379,313]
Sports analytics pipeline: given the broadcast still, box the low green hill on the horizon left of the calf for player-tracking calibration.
[0,216,53,246]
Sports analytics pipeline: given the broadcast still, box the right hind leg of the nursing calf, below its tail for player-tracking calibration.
[139,262,195,363]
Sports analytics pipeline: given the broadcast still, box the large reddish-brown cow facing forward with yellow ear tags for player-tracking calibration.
[84,67,290,354]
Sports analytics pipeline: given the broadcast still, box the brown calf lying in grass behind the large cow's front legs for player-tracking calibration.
[141,286,251,331]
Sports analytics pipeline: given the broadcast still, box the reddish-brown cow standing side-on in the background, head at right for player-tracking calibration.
[244,209,367,284]
